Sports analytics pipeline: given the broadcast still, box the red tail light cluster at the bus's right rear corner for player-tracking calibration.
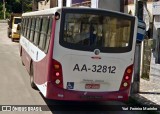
[119,65,133,90]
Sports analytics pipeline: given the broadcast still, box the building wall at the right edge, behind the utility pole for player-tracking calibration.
[124,0,160,80]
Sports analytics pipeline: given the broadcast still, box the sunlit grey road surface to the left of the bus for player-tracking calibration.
[0,23,51,114]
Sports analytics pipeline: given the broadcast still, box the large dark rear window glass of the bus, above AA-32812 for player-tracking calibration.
[62,10,133,51]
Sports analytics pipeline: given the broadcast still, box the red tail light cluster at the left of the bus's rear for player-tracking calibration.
[52,59,63,88]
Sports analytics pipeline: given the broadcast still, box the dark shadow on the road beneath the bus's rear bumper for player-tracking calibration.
[40,93,148,114]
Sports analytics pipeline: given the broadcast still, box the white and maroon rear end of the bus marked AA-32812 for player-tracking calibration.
[47,8,137,101]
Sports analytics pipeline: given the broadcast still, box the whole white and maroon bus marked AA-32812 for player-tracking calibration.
[20,7,137,101]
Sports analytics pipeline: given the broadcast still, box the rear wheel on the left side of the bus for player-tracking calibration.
[30,63,38,90]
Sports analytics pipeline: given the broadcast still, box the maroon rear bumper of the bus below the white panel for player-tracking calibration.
[46,83,129,101]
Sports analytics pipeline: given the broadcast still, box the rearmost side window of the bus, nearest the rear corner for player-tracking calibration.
[44,17,53,53]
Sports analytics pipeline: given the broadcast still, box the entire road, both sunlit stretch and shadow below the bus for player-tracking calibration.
[0,23,149,114]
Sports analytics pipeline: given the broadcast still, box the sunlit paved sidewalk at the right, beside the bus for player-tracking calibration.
[132,56,160,113]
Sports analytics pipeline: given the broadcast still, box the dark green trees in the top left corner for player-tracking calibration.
[0,0,32,19]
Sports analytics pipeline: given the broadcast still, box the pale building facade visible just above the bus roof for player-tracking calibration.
[33,0,123,11]
